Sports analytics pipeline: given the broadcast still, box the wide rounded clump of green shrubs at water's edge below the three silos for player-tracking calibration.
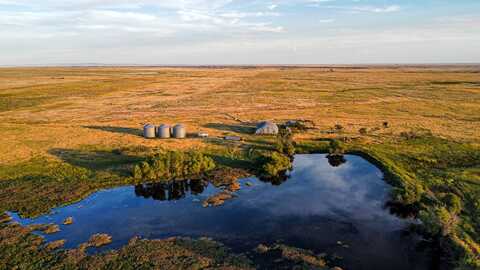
[132,151,215,181]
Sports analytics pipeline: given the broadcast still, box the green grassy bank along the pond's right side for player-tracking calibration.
[359,136,480,267]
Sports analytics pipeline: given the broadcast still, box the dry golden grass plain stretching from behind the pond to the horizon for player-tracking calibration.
[0,67,480,164]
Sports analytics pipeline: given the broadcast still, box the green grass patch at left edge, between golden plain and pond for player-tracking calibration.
[0,158,128,216]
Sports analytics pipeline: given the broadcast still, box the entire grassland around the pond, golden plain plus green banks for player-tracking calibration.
[0,65,480,269]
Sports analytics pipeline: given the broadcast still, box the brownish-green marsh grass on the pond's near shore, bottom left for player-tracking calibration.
[0,221,253,269]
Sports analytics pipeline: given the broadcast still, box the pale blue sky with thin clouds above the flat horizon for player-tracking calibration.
[0,0,480,66]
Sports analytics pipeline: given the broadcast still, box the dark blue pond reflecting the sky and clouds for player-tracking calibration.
[12,154,430,269]
